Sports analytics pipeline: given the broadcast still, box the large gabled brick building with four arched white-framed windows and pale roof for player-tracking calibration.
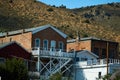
[0,25,67,51]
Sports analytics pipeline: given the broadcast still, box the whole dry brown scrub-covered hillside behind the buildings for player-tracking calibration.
[0,0,120,42]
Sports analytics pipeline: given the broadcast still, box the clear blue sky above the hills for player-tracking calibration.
[38,0,120,8]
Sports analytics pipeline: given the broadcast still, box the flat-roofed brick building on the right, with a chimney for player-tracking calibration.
[67,37,119,59]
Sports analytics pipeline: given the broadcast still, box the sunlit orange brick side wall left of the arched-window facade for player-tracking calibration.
[0,32,32,50]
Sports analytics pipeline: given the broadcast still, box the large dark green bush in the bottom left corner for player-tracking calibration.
[0,59,28,80]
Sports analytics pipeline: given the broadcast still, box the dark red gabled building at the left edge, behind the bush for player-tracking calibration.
[0,42,31,67]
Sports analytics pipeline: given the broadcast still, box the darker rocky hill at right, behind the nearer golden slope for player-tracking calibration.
[73,3,120,32]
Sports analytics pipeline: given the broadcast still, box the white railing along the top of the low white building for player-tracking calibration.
[77,59,120,66]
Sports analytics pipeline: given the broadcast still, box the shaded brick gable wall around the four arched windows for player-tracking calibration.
[32,28,66,50]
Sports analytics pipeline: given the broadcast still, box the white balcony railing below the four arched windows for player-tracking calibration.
[32,48,75,58]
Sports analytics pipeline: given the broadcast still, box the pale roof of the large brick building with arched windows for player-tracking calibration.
[0,24,67,38]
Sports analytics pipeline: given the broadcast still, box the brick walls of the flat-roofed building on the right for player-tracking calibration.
[67,40,119,58]
